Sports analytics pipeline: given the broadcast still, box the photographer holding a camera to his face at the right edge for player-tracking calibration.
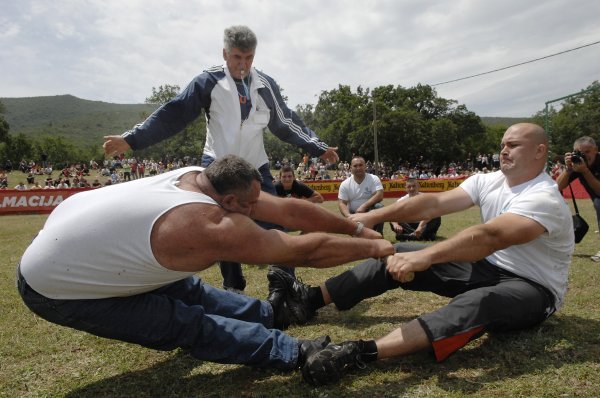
[556,136,600,261]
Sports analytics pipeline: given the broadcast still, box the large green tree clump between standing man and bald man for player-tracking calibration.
[303,84,491,164]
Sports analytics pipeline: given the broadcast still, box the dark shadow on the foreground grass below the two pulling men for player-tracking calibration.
[67,315,600,397]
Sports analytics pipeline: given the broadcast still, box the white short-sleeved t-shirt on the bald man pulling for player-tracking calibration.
[460,171,575,309]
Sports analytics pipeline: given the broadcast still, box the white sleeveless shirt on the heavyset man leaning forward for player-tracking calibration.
[21,167,218,299]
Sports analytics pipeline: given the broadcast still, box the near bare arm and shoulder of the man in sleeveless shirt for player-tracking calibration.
[152,204,394,271]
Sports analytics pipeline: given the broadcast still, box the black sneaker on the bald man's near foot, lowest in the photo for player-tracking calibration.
[302,340,367,386]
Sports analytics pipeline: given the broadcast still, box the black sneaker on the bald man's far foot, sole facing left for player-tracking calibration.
[267,266,315,325]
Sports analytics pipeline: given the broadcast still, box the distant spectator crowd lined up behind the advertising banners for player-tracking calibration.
[0,153,548,190]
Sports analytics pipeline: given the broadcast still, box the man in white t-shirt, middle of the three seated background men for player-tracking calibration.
[338,156,383,234]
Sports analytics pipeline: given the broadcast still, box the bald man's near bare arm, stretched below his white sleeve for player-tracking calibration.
[387,213,545,281]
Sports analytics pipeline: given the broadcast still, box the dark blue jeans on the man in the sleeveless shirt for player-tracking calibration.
[17,268,298,370]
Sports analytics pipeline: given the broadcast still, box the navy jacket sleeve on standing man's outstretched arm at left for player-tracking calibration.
[123,72,216,150]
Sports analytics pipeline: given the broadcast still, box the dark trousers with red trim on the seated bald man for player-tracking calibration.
[325,243,554,361]
